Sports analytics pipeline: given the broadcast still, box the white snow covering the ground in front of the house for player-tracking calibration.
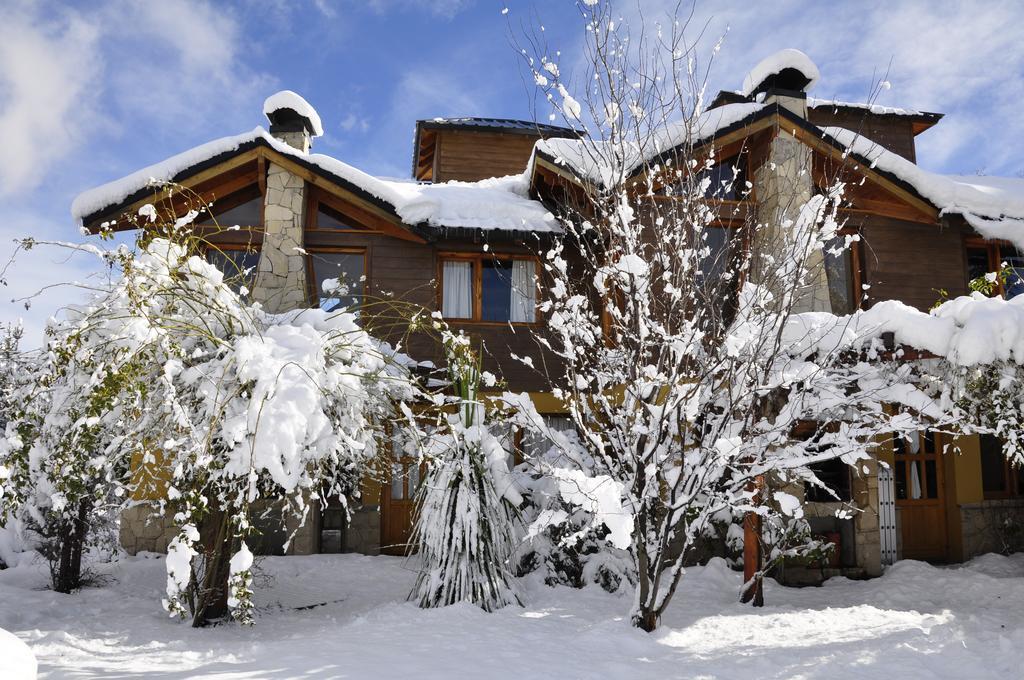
[0,555,1024,680]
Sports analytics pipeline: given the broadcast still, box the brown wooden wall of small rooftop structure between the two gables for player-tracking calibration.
[433,130,538,182]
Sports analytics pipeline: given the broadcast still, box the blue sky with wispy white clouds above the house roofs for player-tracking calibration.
[0,0,1024,339]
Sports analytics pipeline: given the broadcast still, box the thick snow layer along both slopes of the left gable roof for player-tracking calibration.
[72,127,561,232]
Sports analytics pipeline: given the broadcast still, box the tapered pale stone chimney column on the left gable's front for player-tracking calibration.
[253,163,308,313]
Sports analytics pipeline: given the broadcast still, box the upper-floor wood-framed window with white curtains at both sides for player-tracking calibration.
[441,255,537,324]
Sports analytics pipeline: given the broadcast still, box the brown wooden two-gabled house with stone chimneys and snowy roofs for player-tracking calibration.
[73,52,1024,576]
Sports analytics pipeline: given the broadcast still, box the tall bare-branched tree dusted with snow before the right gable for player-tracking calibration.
[507,2,937,631]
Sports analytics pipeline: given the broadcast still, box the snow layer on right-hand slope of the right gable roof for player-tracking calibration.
[821,127,1024,248]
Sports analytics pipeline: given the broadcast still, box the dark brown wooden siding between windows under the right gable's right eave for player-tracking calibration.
[850,215,967,311]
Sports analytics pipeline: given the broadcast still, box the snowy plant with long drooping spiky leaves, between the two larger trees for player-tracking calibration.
[410,330,522,611]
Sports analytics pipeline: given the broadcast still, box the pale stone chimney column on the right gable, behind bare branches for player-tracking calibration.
[751,120,831,313]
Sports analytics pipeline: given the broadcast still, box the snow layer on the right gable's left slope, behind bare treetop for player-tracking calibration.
[530,102,765,186]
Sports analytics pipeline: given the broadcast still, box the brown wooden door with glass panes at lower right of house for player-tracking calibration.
[893,432,948,562]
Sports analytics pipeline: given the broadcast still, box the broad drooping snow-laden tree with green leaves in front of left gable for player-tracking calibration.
[0,193,419,625]
